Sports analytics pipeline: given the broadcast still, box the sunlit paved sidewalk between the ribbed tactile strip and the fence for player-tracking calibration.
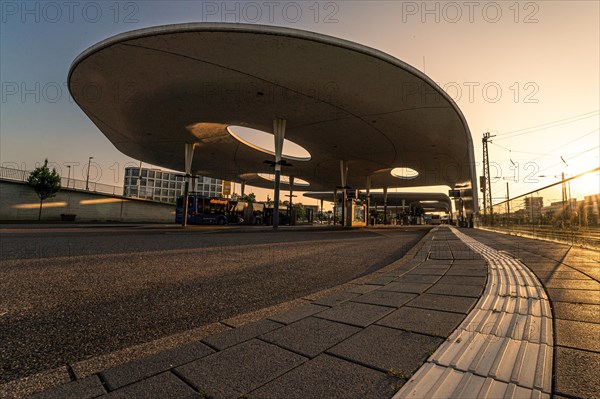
[461,229,600,398]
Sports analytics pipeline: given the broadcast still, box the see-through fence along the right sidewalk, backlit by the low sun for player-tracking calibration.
[476,168,600,248]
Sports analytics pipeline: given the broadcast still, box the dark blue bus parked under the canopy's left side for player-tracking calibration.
[175,193,247,225]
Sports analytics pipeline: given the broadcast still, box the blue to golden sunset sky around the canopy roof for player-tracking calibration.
[0,1,600,209]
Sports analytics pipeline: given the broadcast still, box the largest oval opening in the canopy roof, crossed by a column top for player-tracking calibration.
[227,125,310,161]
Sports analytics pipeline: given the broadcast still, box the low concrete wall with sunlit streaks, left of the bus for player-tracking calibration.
[0,179,175,223]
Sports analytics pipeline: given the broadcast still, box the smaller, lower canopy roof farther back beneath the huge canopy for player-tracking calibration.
[304,191,452,212]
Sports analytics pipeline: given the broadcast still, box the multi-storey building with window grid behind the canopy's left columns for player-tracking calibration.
[123,167,223,203]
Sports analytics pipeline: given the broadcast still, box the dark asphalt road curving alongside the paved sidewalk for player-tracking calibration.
[0,227,427,383]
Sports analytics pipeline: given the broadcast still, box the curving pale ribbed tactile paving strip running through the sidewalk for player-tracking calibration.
[394,228,554,399]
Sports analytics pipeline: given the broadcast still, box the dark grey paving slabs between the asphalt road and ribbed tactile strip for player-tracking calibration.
[25,228,487,399]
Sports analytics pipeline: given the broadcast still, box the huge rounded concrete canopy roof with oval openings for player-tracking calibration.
[68,23,476,211]
